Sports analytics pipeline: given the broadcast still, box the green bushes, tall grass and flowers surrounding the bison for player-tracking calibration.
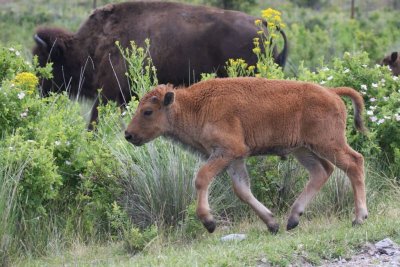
[0,0,400,266]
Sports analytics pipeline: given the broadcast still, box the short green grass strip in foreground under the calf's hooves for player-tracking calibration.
[15,198,400,266]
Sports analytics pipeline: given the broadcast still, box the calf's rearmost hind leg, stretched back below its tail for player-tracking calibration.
[324,146,368,225]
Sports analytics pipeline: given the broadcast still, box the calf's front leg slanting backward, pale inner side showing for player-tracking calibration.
[227,159,279,234]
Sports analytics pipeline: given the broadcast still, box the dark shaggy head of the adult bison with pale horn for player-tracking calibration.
[32,28,79,96]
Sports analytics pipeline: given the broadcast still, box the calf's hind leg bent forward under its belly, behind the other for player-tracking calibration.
[286,148,334,230]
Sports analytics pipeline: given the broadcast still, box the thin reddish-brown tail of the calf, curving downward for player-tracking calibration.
[332,87,367,133]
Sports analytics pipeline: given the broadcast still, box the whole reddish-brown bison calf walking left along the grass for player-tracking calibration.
[125,78,368,233]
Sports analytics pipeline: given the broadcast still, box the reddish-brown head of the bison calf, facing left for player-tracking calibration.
[125,85,175,146]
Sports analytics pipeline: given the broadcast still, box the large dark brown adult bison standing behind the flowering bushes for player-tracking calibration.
[33,2,287,126]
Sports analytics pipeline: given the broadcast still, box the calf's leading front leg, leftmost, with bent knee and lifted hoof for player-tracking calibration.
[195,155,231,233]
